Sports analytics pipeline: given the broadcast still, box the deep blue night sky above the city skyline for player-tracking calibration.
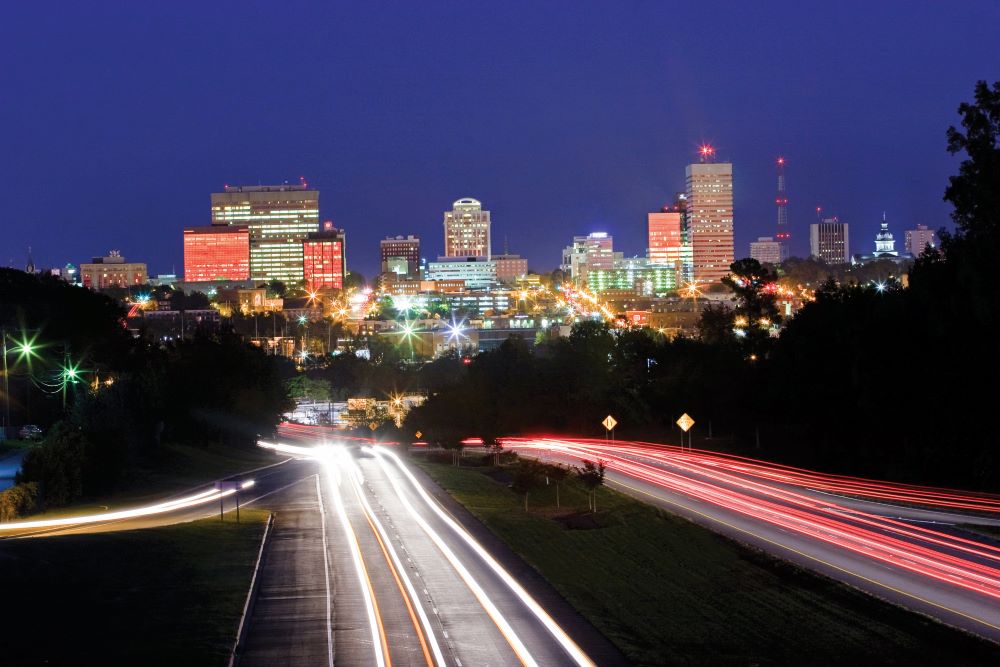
[0,0,1000,278]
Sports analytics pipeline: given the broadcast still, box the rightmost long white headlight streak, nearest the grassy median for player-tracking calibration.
[365,447,594,666]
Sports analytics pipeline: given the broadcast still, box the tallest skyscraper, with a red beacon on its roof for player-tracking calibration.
[684,152,736,283]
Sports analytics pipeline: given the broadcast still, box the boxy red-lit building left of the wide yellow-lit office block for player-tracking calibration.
[184,225,250,283]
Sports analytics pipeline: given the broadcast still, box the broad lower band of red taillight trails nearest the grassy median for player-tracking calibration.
[505,439,1000,604]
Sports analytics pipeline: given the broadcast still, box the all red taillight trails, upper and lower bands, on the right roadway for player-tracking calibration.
[504,438,1000,600]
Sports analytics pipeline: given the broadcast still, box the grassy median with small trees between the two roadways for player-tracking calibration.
[421,463,1000,665]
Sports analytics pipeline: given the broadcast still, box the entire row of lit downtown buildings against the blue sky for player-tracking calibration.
[25,157,938,294]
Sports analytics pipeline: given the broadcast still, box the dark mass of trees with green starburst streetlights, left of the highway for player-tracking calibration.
[0,269,294,505]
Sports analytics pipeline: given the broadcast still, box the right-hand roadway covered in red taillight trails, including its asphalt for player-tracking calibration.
[504,437,1000,641]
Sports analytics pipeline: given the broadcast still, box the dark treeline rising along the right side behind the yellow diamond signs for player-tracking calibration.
[408,82,1000,491]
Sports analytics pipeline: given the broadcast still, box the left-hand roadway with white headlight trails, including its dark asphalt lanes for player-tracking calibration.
[239,430,623,667]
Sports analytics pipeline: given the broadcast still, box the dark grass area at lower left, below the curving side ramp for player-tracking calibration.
[0,510,267,667]
